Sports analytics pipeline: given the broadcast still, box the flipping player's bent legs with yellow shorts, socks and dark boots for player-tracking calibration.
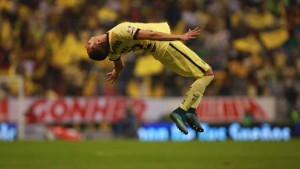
[158,41,213,134]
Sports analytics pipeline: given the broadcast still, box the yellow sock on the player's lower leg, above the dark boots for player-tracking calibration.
[179,75,214,111]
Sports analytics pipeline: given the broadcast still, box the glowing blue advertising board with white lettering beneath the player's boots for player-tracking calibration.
[137,123,300,142]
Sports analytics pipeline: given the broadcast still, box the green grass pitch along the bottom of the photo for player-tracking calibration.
[0,139,300,169]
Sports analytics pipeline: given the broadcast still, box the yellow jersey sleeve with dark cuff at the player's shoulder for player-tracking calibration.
[109,22,140,41]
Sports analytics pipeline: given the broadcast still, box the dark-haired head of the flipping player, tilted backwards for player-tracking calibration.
[86,34,109,61]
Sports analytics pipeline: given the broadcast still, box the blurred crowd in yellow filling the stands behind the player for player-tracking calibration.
[0,0,300,97]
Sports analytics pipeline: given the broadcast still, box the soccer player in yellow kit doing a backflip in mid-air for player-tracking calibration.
[86,22,214,134]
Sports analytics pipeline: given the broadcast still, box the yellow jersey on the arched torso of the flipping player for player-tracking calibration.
[107,22,170,60]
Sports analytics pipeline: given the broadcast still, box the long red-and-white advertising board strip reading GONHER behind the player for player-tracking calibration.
[7,97,276,123]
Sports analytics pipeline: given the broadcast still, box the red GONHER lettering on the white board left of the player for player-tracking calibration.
[26,97,146,122]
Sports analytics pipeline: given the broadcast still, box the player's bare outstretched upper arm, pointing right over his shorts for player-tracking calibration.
[135,28,201,41]
